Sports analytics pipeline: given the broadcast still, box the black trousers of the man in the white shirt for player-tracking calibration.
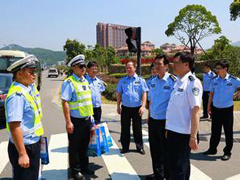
[167,131,190,180]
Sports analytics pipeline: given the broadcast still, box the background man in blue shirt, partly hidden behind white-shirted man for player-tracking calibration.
[200,63,215,119]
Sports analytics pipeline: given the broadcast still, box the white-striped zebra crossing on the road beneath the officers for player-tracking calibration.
[0,130,240,180]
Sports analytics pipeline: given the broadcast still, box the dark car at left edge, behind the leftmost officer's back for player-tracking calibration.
[0,73,13,129]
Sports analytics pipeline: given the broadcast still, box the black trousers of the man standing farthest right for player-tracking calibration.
[209,106,233,155]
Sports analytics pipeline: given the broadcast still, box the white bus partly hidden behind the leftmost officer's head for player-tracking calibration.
[0,50,42,90]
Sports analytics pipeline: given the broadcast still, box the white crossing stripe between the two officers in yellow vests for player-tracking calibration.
[42,133,68,180]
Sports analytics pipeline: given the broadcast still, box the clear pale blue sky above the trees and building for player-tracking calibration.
[0,0,240,51]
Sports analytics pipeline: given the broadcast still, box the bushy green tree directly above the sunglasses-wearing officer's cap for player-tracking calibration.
[63,39,86,62]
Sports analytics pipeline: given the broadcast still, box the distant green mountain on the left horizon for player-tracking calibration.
[1,44,66,66]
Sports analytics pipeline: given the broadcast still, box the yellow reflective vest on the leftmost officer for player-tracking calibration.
[5,84,44,136]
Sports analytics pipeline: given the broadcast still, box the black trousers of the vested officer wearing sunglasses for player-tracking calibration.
[68,117,90,175]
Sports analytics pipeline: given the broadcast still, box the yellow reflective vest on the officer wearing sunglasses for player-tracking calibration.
[65,76,93,116]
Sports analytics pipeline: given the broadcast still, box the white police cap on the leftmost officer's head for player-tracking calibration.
[7,55,39,72]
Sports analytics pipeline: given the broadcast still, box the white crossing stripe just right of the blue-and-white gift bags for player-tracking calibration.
[102,139,140,180]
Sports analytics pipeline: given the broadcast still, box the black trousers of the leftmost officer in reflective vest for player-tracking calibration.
[8,141,41,180]
